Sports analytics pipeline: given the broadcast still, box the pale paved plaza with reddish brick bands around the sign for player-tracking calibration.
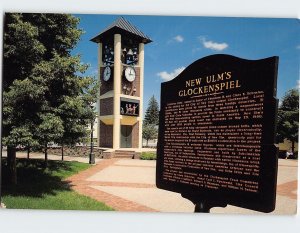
[2,153,298,214]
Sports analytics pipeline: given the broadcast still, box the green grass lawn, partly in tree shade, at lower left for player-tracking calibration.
[2,159,113,210]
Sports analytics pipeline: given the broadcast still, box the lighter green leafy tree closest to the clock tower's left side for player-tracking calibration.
[32,51,99,159]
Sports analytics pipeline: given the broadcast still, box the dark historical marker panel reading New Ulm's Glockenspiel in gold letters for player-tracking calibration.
[156,55,278,212]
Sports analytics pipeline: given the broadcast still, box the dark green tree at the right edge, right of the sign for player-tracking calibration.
[277,89,299,152]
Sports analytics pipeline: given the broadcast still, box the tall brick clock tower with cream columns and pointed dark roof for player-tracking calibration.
[91,17,152,158]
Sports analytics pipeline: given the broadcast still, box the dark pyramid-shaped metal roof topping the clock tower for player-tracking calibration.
[91,17,152,44]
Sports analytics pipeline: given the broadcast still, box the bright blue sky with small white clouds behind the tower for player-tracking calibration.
[73,14,300,111]
